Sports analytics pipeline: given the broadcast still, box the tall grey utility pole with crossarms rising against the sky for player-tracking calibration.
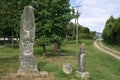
[75,5,81,44]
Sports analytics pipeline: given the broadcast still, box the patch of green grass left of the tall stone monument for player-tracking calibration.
[0,47,18,75]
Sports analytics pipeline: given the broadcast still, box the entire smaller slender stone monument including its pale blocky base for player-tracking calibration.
[75,44,89,80]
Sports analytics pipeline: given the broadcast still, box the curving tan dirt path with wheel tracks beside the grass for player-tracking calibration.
[94,40,120,60]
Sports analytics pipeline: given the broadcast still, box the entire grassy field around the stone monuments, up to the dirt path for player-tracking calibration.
[0,40,120,80]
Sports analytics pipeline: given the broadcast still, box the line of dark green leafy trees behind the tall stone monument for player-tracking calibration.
[0,0,94,52]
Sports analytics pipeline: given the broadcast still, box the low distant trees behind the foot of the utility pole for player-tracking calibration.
[67,22,95,40]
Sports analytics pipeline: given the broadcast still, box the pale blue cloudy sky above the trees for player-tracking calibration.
[70,0,120,32]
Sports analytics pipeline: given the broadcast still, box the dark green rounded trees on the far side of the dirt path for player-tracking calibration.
[102,16,120,44]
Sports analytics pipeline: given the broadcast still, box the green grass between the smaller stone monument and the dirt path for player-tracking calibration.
[86,46,120,80]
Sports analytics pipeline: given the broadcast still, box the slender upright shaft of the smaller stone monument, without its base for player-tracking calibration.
[78,44,85,72]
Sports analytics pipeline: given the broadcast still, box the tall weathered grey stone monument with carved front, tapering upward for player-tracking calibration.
[17,6,39,76]
